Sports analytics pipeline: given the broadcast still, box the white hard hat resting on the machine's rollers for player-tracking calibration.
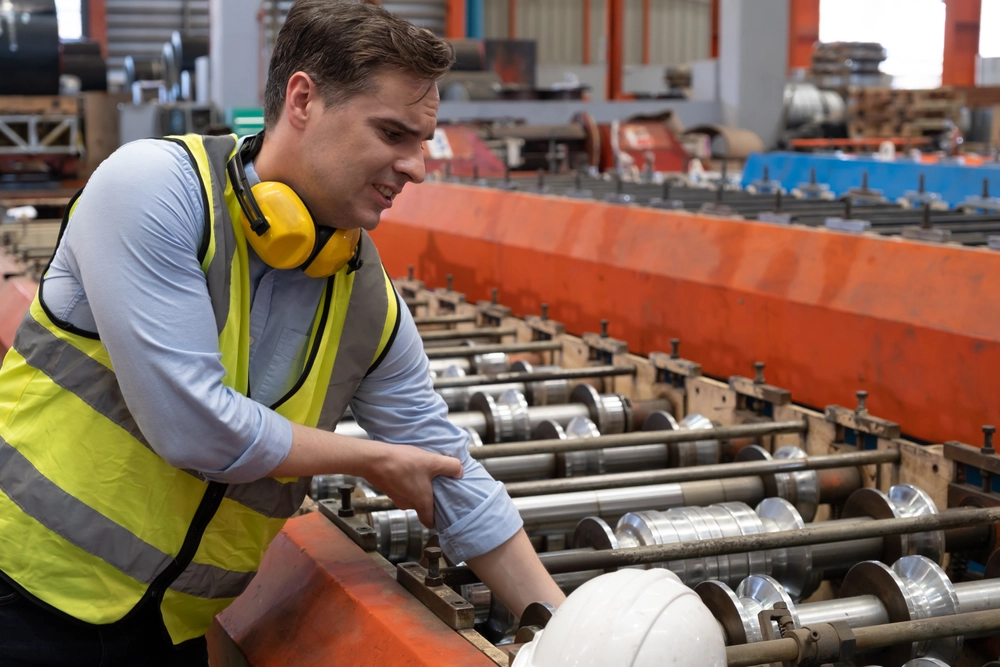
[513,568,726,667]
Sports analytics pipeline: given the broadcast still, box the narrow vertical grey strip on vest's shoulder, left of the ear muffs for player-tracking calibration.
[202,136,236,333]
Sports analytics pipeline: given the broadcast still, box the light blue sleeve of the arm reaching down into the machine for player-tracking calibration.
[351,308,522,563]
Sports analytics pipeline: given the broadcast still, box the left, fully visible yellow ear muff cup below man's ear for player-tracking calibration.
[240,181,316,269]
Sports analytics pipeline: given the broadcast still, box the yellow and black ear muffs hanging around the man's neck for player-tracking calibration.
[227,132,362,278]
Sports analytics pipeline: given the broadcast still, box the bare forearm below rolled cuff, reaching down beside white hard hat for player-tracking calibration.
[468,530,566,617]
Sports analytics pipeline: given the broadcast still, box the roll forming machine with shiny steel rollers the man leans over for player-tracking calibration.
[213,274,1000,667]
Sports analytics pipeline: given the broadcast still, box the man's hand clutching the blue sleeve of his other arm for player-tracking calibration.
[362,442,464,528]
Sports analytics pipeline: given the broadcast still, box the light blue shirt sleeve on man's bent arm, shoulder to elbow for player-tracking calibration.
[45,140,292,482]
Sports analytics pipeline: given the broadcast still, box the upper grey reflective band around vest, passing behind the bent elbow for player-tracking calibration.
[14,311,306,519]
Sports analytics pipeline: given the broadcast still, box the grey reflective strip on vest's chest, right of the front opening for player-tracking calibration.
[316,230,390,431]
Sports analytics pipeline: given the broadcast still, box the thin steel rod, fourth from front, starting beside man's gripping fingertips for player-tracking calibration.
[470,420,809,459]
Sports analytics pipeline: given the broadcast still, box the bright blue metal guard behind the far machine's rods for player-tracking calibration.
[742,152,1000,208]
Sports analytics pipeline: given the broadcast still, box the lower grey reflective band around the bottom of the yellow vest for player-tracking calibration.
[0,438,255,599]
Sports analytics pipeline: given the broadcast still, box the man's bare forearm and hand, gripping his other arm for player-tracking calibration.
[268,423,464,528]
